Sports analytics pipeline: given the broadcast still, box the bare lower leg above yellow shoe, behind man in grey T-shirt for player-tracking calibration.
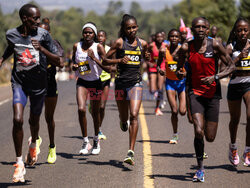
[45,96,58,148]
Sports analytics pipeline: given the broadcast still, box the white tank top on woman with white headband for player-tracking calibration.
[75,42,102,81]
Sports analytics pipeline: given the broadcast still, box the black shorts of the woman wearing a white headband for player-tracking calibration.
[76,78,102,100]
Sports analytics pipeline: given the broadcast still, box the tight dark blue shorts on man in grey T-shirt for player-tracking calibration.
[12,84,45,115]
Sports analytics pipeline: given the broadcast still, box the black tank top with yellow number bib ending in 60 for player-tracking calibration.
[116,38,142,88]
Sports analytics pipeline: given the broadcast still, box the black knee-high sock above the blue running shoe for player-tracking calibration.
[194,137,204,170]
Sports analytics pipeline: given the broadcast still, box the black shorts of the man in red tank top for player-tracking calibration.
[189,93,220,122]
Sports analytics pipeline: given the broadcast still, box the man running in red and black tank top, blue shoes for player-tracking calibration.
[177,17,234,182]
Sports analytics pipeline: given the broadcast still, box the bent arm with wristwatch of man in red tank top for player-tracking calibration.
[201,40,235,85]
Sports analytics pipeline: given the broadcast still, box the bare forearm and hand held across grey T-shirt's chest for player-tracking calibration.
[31,39,61,67]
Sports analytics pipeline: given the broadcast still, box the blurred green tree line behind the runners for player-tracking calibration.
[0,0,250,54]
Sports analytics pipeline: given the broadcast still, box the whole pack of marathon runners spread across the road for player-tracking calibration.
[0,4,250,182]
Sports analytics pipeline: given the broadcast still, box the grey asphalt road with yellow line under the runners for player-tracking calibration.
[0,81,250,188]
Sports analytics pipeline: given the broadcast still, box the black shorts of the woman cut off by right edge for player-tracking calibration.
[227,82,250,101]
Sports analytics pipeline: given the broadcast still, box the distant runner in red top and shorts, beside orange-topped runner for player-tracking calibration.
[148,32,166,116]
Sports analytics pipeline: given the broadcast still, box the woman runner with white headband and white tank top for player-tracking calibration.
[72,22,106,155]
